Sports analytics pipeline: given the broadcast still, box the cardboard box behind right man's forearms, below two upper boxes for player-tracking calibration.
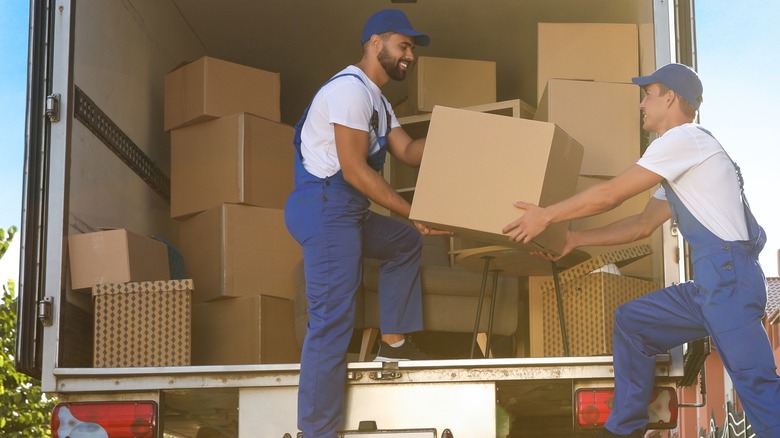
[570,176,655,278]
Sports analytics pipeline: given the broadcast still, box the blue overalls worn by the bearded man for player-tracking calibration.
[285,74,423,438]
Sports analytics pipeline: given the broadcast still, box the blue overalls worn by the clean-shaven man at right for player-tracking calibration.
[606,165,780,438]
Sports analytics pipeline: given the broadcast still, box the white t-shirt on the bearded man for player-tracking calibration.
[301,65,401,178]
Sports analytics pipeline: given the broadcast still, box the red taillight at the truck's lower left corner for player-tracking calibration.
[51,402,157,438]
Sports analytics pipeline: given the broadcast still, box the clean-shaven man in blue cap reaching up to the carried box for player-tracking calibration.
[503,64,780,438]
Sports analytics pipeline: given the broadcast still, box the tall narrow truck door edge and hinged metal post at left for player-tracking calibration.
[16,0,73,390]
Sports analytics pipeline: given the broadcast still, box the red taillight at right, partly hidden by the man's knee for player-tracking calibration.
[574,387,677,429]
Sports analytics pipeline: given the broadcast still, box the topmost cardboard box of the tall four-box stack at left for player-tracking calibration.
[163,56,281,131]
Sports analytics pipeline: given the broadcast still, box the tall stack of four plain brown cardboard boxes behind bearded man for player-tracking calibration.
[165,57,302,365]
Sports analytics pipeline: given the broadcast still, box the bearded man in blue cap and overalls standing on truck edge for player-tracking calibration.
[285,10,445,438]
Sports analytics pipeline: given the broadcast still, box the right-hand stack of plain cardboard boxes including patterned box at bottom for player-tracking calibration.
[530,23,658,356]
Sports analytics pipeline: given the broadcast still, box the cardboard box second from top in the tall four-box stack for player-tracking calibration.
[171,113,295,219]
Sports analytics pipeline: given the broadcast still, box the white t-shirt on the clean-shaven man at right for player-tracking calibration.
[637,123,749,241]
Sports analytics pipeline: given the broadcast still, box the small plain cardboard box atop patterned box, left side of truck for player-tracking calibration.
[68,229,193,367]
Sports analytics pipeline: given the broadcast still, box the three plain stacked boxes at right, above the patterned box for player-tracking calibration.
[535,23,653,277]
